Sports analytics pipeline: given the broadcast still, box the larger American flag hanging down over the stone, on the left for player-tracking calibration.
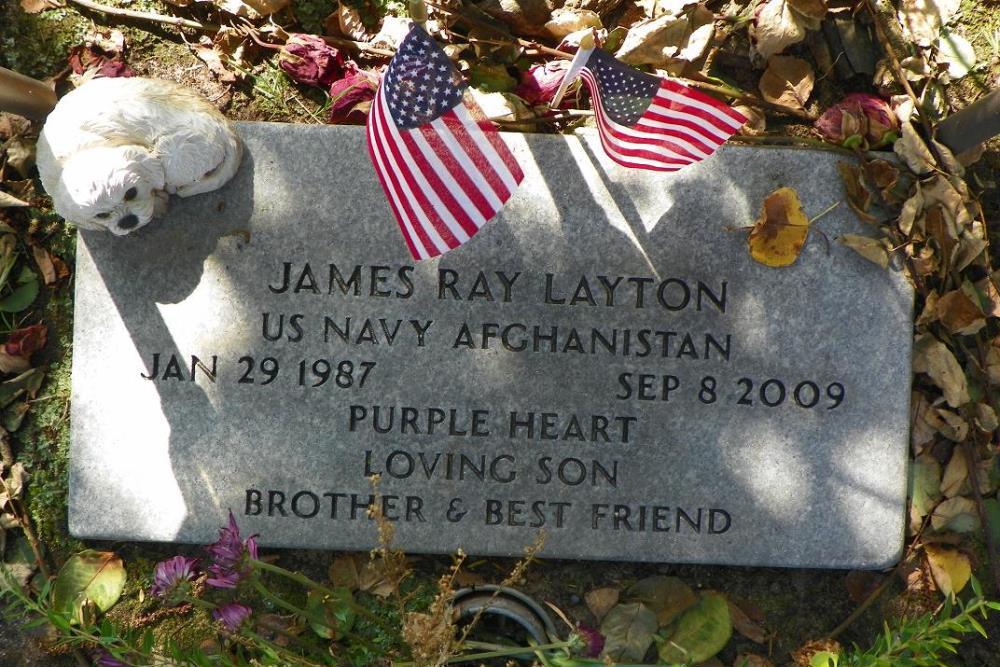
[368,23,524,259]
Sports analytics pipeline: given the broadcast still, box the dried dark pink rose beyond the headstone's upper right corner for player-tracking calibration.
[814,93,899,148]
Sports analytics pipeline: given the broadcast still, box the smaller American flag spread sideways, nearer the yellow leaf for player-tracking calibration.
[580,49,747,171]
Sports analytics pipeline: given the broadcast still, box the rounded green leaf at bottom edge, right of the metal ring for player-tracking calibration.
[659,593,733,662]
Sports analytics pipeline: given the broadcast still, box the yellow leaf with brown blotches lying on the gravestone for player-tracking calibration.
[749,188,809,267]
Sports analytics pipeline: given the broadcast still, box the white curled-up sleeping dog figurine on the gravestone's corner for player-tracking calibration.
[37,78,243,236]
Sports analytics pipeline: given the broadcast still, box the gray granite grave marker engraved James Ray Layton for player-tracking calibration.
[70,124,912,568]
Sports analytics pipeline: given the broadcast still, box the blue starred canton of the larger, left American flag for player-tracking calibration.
[382,24,467,130]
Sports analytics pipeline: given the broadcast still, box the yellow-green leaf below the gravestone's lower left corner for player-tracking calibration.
[52,549,125,623]
